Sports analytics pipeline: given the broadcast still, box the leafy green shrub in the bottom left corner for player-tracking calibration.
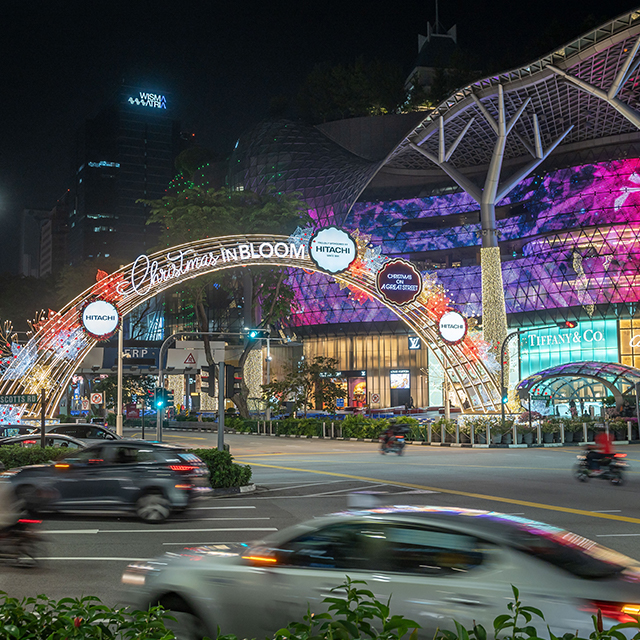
[0,592,175,640]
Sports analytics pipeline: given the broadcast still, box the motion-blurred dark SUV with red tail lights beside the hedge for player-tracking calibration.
[2,440,212,522]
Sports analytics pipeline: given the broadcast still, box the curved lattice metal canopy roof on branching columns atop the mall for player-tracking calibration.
[384,10,640,179]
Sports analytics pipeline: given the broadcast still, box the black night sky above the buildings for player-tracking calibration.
[0,0,634,270]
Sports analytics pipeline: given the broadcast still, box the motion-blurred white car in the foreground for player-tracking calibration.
[122,507,640,640]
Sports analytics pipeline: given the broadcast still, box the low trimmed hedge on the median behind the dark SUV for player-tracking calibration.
[0,444,251,489]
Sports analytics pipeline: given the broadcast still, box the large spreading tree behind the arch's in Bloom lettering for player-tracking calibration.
[140,187,311,417]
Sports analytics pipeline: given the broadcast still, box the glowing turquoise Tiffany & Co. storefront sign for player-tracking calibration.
[520,320,619,378]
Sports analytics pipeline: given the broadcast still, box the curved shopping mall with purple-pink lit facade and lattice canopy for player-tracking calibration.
[218,12,640,416]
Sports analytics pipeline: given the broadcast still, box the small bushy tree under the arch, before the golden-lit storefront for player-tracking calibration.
[262,356,346,416]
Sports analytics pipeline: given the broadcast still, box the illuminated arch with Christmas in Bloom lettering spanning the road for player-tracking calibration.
[0,235,500,416]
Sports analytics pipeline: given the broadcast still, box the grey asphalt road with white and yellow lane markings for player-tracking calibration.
[0,432,640,604]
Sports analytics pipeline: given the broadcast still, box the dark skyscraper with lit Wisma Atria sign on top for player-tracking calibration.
[69,85,180,263]
